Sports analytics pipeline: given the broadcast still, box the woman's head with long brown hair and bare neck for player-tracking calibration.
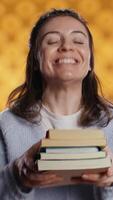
[8,9,111,126]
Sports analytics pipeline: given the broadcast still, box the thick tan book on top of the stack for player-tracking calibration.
[41,129,106,147]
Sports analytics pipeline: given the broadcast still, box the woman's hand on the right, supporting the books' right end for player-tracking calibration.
[82,147,113,187]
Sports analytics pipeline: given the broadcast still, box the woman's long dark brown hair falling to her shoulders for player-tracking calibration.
[7,9,112,127]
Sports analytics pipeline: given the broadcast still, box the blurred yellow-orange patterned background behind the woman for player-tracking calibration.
[0,0,113,110]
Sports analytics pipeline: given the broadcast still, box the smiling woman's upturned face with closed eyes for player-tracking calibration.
[38,16,90,82]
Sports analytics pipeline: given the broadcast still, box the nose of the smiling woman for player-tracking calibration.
[59,40,74,52]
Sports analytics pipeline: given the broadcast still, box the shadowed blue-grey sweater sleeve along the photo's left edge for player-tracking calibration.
[0,130,32,200]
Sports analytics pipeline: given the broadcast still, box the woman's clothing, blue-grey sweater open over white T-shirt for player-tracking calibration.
[0,108,113,200]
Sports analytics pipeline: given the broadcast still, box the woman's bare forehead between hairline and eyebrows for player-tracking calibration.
[40,16,88,36]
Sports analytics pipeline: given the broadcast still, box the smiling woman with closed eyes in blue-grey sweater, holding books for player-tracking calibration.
[0,9,113,200]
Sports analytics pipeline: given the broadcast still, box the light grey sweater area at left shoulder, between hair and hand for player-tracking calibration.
[0,109,45,160]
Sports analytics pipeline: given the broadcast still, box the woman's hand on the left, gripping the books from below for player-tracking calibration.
[13,141,62,190]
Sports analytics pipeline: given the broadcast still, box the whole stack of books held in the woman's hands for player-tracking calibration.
[37,129,111,185]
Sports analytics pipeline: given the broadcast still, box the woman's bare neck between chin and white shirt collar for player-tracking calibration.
[42,80,82,115]
